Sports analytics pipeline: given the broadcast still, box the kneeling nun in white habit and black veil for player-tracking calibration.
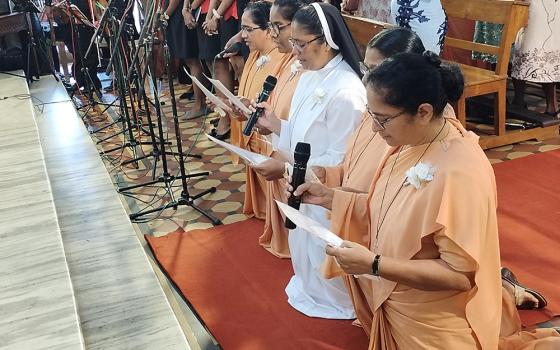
[255,3,366,319]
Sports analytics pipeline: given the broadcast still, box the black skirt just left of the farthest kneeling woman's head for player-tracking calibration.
[196,14,239,61]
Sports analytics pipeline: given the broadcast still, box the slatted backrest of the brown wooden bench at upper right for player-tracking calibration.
[441,0,529,75]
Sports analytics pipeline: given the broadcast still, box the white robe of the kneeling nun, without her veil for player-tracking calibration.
[278,55,366,319]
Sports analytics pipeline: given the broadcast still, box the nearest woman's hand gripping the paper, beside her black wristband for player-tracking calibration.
[326,241,375,275]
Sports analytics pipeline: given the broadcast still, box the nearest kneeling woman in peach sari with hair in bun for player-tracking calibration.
[294,53,560,350]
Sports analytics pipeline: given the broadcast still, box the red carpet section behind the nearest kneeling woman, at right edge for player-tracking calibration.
[494,151,560,325]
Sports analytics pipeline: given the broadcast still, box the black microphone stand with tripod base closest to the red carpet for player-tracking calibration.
[124,16,222,225]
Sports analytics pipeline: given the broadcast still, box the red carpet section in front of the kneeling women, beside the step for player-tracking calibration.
[146,219,368,350]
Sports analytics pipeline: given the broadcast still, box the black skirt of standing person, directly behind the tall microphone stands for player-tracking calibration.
[165,7,198,59]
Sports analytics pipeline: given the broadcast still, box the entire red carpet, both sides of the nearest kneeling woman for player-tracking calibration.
[146,151,560,350]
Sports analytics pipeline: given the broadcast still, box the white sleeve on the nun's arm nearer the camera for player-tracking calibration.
[307,89,366,166]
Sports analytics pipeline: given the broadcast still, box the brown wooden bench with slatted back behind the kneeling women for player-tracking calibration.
[441,0,558,148]
